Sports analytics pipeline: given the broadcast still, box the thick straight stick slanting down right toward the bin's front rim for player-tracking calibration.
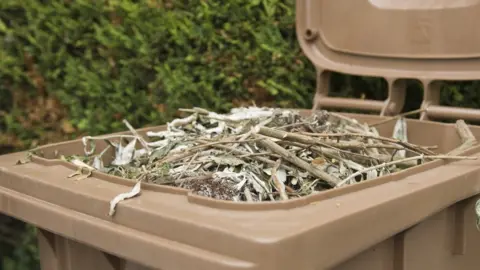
[258,134,340,186]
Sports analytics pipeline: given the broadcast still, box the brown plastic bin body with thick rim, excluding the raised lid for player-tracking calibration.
[0,111,480,270]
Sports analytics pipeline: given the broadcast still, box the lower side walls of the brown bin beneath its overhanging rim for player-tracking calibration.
[29,194,480,270]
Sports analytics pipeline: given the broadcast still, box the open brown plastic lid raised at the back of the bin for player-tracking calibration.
[296,0,480,80]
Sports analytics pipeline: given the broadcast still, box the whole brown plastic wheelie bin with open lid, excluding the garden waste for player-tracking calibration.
[0,0,480,270]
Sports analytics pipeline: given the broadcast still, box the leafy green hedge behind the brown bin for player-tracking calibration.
[0,0,480,270]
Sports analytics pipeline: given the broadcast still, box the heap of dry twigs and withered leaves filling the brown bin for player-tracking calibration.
[65,107,469,204]
